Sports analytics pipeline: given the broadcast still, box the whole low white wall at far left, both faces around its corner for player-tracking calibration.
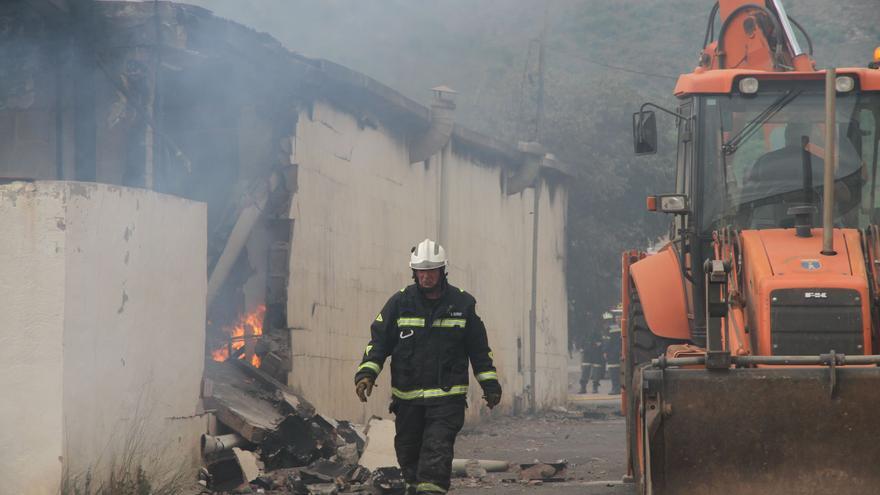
[0,182,206,494]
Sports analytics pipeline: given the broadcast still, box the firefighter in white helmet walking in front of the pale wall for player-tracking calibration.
[355,239,501,494]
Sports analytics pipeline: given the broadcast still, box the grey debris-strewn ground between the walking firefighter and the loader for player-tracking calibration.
[452,383,635,495]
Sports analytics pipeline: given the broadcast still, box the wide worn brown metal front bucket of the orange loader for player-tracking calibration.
[641,367,880,495]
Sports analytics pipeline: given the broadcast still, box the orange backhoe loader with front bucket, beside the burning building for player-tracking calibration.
[622,0,880,495]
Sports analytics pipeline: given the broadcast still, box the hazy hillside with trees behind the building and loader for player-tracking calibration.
[191,0,880,335]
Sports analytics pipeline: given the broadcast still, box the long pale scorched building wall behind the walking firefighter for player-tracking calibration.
[288,103,567,421]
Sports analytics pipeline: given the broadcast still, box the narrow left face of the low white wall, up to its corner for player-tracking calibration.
[0,182,65,495]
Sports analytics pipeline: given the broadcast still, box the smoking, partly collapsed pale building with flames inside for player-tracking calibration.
[0,0,571,493]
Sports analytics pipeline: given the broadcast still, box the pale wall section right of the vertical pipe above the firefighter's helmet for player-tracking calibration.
[442,152,568,414]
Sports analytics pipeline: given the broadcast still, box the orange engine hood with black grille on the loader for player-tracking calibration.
[740,229,871,356]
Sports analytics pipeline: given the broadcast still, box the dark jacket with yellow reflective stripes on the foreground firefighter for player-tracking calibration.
[355,284,500,404]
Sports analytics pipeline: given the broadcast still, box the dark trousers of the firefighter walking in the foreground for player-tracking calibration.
[391,400,465,493]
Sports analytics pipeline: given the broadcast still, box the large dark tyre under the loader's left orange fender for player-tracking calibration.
[623,280,687,487]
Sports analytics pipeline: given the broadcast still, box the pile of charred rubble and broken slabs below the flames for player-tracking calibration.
[201,359,404,495]
